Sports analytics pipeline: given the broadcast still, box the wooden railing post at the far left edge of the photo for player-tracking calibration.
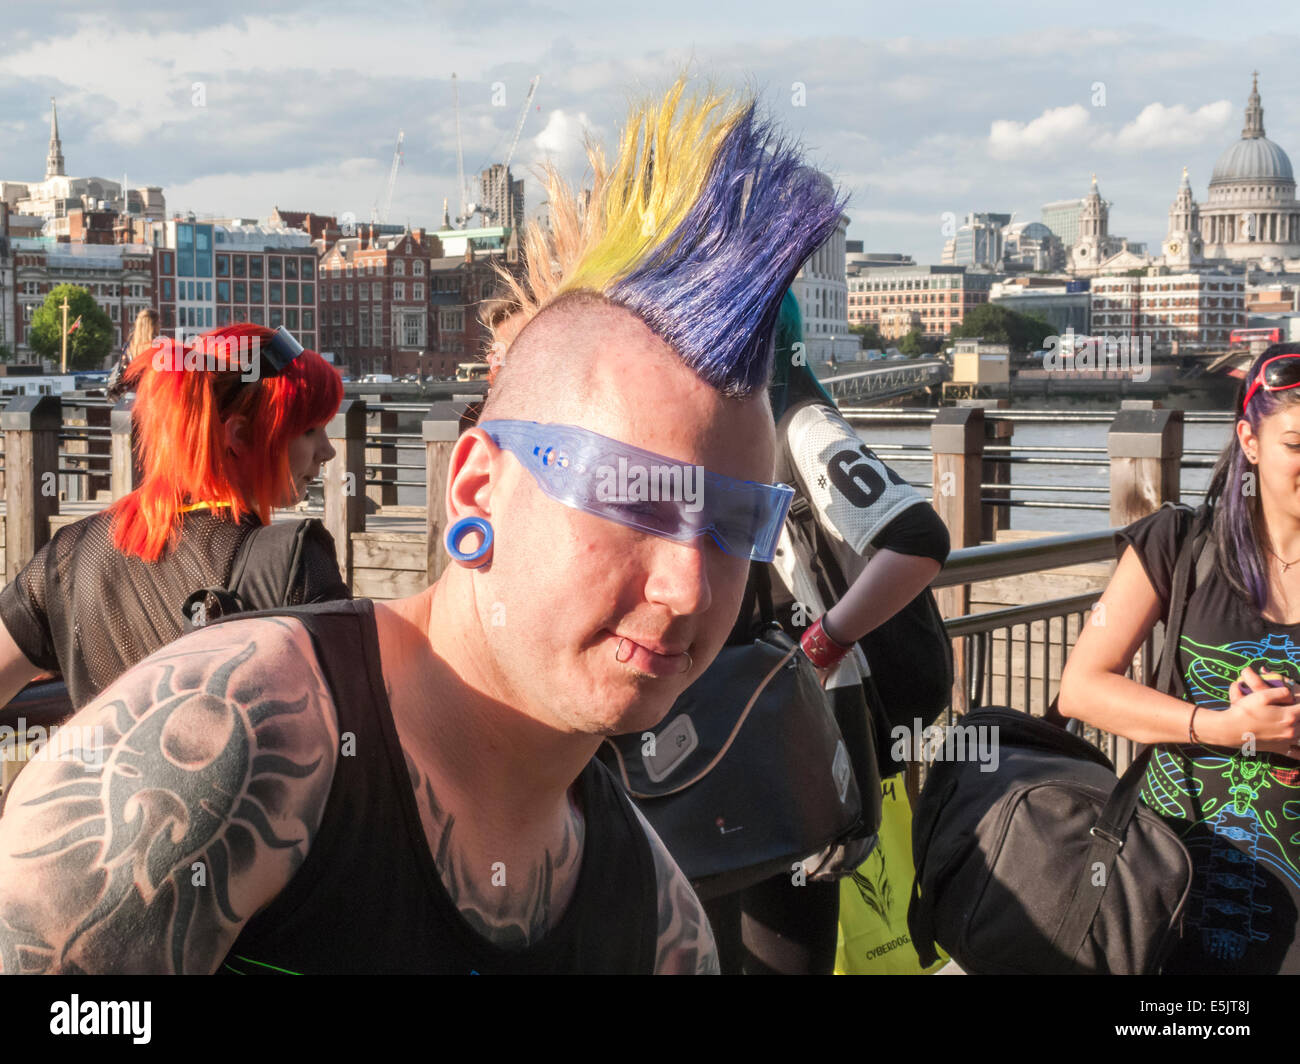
[0,395,64,580]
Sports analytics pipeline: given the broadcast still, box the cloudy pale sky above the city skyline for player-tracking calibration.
[0,0,1300,261]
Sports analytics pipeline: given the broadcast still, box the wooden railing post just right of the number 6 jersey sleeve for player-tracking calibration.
[925,406,984,800]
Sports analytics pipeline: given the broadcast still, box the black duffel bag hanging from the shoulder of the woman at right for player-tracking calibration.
[907,504,1205,974]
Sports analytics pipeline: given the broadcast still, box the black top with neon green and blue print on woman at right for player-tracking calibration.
[1117,507,1300,974]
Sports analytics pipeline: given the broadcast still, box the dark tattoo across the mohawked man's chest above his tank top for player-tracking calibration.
[406,757,586,950]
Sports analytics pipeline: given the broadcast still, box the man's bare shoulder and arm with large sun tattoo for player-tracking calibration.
[0,618,338,973]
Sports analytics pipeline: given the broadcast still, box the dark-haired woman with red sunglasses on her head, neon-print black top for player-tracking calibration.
[1060,343,1300,974]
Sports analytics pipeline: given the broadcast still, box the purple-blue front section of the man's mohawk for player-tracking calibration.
[608,105,846,397]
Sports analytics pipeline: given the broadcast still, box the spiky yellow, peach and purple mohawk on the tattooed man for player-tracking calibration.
[491,78,844,397]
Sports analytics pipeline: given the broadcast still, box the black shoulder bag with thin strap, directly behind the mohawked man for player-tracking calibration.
[598,563,880,900]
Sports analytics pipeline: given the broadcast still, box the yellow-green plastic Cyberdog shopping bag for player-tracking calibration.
[835,774,948,976]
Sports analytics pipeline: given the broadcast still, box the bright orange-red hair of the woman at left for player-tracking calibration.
[111,324,343,562]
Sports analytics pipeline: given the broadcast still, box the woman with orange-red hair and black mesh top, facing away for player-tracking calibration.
[0,324,350,708]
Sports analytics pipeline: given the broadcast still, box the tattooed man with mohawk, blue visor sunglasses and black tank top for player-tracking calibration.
[0,82,841,973]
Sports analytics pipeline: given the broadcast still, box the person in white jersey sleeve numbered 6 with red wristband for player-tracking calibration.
[705,293,949,974]
